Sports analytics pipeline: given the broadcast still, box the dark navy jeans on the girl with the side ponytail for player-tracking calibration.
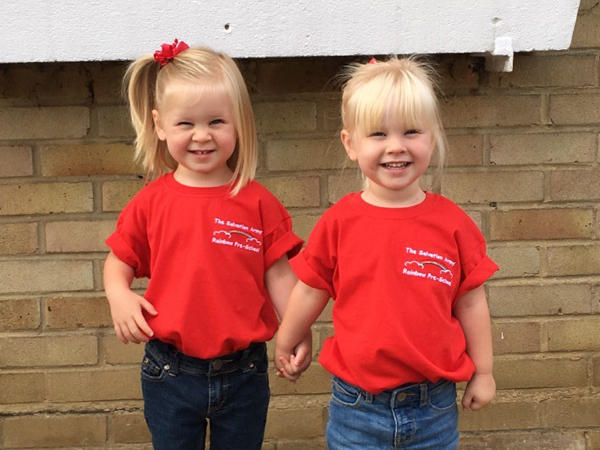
[142,340,270,450]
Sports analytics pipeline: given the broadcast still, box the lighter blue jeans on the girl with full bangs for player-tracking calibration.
[327,377,458,450]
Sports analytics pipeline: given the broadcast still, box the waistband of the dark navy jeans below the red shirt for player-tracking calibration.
[146,339,267,375]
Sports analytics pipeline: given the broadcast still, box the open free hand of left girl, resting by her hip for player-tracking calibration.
[108,289,158,344]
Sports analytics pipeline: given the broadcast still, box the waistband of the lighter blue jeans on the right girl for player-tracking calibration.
[336,377,455,408]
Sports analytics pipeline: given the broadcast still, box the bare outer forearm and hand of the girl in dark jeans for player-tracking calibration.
[104,252,157,344]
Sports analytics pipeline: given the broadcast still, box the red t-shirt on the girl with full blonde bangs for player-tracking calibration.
[292,193,498,394]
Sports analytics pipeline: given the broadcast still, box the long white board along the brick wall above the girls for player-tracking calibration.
[0,0,579,63]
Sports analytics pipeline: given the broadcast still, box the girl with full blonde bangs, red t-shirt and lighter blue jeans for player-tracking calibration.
[275,57,498,450]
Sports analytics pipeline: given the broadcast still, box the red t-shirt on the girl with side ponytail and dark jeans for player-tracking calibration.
[106,174,302,359]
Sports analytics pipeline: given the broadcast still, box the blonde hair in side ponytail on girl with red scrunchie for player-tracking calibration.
[123,47,258,195]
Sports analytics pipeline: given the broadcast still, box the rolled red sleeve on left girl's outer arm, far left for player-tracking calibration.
[106,198,150,278]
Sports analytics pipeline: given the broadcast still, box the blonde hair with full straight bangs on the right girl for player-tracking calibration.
[342,56,448,184]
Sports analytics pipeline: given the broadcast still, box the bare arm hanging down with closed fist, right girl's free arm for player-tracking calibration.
[454,286,496,411]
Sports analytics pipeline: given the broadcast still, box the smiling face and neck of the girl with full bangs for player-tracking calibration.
[341,117,435,207]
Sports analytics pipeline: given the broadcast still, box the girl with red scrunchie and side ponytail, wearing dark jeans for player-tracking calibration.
[104,40,311,450]
